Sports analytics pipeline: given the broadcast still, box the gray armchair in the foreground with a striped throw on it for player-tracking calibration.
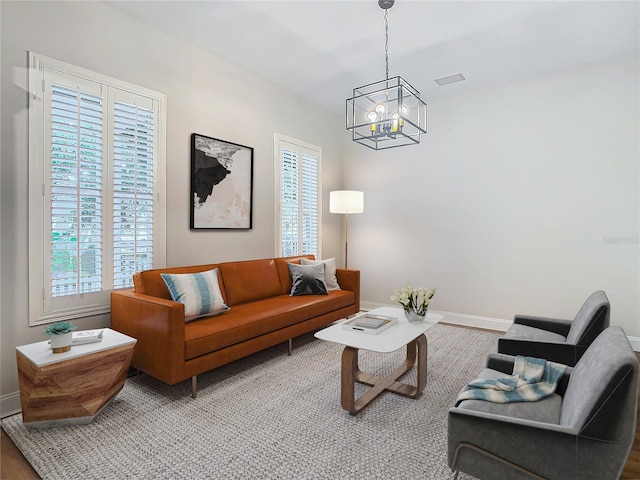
[448,327,638,480]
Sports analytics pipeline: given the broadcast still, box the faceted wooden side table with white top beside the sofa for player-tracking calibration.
[16,328,136,427]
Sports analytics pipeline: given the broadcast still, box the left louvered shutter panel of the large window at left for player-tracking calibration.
[49,82,103,297]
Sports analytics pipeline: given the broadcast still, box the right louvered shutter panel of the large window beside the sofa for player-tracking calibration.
[113,94,154,288]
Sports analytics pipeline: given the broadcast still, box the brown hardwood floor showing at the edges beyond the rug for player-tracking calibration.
[0,352,640,480]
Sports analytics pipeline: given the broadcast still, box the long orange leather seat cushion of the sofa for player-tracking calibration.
[184,290,355,359]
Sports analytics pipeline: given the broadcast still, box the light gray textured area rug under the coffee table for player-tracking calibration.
[2,325,498,480]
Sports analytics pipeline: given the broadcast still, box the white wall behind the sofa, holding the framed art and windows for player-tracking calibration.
[0,2,343,413]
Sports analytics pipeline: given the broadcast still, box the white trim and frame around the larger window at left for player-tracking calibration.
[28,52,166,326]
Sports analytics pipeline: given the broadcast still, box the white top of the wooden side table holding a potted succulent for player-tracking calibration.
[16,328,137,367]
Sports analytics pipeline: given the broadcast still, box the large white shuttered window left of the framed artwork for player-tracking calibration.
[29,53,165,325]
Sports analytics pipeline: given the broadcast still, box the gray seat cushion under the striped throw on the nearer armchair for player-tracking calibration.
[458,368,562,425]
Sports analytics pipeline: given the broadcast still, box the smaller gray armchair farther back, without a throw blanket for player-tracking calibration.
[498,290,611,366]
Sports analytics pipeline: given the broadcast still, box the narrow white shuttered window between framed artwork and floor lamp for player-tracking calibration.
[274,133,322,258]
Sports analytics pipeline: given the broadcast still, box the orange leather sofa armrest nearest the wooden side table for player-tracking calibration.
[111,289,185,385]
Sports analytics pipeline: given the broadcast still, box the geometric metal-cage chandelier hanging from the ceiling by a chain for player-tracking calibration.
[347,0,427,150]
